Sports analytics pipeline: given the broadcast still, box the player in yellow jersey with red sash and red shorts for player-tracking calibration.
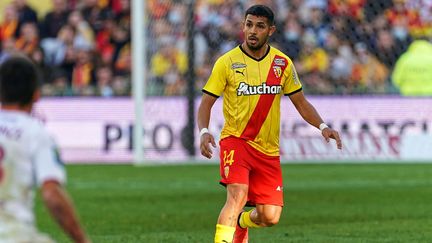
[198,5,342,243]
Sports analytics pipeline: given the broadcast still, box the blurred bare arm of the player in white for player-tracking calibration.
[42,180,90,243]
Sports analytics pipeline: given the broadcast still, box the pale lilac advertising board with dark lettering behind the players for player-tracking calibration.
[36,97,432,163]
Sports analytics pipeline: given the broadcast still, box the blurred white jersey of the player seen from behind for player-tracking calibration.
[0,110,66,226]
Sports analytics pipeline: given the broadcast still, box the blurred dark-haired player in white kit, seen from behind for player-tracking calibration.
[0,56,90,243]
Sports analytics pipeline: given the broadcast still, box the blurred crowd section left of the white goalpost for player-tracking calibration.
[0,0,131,97]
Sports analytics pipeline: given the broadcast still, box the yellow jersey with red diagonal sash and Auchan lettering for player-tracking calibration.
[203,46,302,156]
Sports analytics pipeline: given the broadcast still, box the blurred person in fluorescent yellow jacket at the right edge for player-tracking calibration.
[392,40,432,96]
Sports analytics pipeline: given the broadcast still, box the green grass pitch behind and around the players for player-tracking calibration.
[36,164,432,243]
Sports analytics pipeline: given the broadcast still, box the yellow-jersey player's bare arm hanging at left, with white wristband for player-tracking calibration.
[198,93,217,159]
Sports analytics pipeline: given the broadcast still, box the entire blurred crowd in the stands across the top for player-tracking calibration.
[0,0,432,97]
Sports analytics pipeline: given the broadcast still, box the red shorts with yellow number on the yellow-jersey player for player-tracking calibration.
[220,137,283,206]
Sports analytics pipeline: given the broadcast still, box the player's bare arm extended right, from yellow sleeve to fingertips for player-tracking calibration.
[289,91,342,149]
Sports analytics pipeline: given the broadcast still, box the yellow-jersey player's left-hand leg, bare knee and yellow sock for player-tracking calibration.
[215,184,248,243]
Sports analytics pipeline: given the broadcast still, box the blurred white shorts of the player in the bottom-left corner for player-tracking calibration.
[0,216,55,243]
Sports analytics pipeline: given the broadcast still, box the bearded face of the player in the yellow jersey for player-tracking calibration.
[243,14,275,50]
